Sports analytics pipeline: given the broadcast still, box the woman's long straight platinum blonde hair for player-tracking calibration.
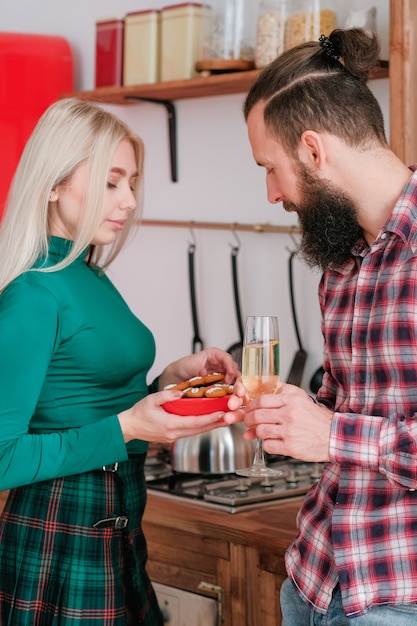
[0,98,144,293]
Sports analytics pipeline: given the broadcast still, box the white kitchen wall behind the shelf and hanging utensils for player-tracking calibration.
[0,0,389,386]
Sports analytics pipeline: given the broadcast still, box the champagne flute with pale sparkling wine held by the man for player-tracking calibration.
[236,316,282,477]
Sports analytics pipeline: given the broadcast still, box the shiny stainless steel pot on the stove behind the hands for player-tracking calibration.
[171,422,255,474]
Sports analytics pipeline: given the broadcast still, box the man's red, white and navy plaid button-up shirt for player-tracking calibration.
[286,166,417,615]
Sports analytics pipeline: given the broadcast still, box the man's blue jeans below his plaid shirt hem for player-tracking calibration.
[281,578,417,626]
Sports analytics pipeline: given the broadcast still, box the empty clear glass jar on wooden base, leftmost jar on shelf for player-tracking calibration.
[198,0,259,71]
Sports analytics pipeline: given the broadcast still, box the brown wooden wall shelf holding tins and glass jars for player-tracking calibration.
[66,61,388,104]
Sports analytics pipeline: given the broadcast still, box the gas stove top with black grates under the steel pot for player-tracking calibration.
[145,448,323,513]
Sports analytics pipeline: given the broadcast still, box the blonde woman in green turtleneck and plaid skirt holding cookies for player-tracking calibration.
[0,99,237,626]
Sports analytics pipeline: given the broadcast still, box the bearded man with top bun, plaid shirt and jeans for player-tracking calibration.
[225,29,417,626]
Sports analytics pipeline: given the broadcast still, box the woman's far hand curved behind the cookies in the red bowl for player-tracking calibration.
[159,348,239,390]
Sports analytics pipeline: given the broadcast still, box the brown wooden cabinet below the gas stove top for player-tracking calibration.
[143,492,302,626]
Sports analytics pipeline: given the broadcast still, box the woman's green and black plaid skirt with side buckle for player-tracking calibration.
[0,455,163,626]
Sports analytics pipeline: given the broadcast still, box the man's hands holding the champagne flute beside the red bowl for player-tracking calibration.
[224,380,333,462]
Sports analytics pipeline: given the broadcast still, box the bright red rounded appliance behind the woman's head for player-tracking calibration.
[0,32,74,218]
